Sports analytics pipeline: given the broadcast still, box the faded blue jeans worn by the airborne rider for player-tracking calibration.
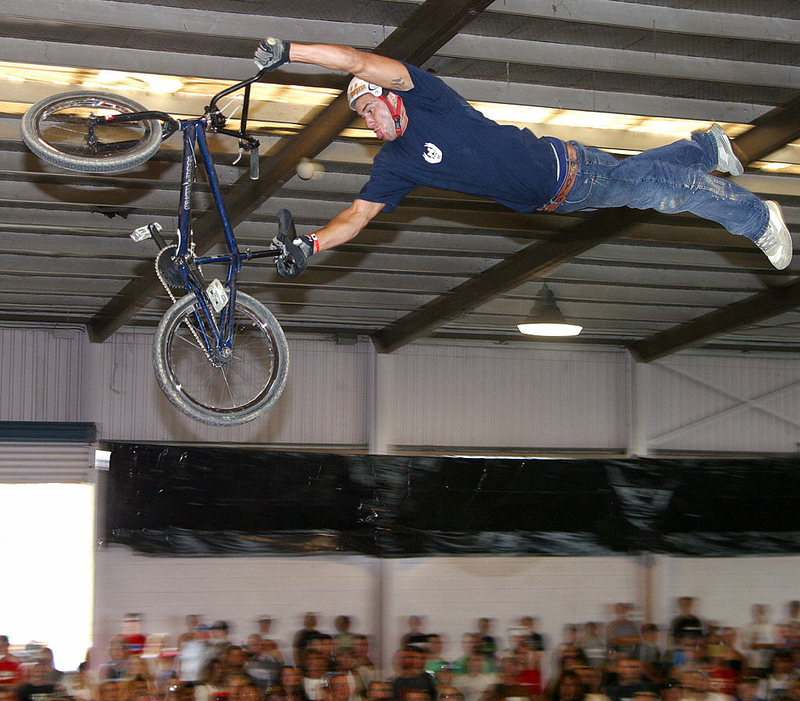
[556,132,769,240]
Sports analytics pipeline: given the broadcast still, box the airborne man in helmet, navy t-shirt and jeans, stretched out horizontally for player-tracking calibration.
[255,37,792,269]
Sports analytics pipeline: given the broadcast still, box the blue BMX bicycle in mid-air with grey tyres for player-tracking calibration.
[22,70,305,426]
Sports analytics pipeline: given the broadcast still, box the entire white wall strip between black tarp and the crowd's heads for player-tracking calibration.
[95,546,800,669]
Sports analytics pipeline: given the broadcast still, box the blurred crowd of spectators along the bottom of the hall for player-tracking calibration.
[0,597,800,701]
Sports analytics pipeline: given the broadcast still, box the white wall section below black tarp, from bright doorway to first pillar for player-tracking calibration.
[95,546,380,662]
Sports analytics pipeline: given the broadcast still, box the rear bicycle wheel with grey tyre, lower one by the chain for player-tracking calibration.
[153,292,289,426]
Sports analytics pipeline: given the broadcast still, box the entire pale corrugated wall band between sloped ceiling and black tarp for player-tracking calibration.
[0,329,800,455]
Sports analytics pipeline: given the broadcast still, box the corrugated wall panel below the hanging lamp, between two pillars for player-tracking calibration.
[390,346,628,452]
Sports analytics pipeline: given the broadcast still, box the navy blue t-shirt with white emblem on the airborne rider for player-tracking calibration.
[358,64,558,212]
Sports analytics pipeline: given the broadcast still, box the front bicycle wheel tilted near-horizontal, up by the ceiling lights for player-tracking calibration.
[21,91,161,173]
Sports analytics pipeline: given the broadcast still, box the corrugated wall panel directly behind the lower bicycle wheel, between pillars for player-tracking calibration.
[90,333,372,447]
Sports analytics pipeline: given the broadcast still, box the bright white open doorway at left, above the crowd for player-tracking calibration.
[0,484,94,671]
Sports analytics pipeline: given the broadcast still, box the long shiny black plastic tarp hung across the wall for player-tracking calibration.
[106,443,800,557]
